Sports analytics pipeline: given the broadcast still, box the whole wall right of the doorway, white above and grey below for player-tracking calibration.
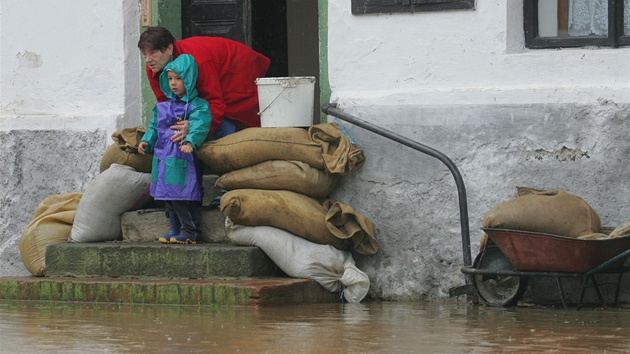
[327,0,630,300]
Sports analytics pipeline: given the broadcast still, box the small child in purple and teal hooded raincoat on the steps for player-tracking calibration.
[138,54,212,243]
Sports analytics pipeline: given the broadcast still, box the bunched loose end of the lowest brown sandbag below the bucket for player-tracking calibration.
[324,200,378,255]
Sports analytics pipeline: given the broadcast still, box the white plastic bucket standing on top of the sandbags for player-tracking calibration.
[256,76,315,127]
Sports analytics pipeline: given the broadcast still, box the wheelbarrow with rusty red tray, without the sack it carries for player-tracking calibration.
[462,228,630,309]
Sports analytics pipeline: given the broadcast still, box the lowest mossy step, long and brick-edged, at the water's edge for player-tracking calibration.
[0,277,340,306]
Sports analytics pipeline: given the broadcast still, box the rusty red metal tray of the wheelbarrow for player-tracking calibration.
[483,228,630,273]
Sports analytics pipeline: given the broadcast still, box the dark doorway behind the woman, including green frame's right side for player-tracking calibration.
[181,0,320,124]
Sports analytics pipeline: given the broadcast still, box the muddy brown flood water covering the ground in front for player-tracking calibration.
[0,301,630,353]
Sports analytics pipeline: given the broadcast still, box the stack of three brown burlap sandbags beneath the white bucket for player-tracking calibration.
[196,123,378,255]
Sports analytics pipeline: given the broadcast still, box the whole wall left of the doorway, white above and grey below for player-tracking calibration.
[0,0,142,275]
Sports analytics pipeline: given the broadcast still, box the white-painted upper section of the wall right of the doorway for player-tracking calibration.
[328,0,630,109]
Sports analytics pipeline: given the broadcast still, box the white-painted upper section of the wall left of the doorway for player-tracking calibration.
[0,0,142,132]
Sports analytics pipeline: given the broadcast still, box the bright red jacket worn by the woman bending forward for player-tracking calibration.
[146,36,270,131]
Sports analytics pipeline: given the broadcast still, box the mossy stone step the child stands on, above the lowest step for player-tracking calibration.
[46,242,286,279]
